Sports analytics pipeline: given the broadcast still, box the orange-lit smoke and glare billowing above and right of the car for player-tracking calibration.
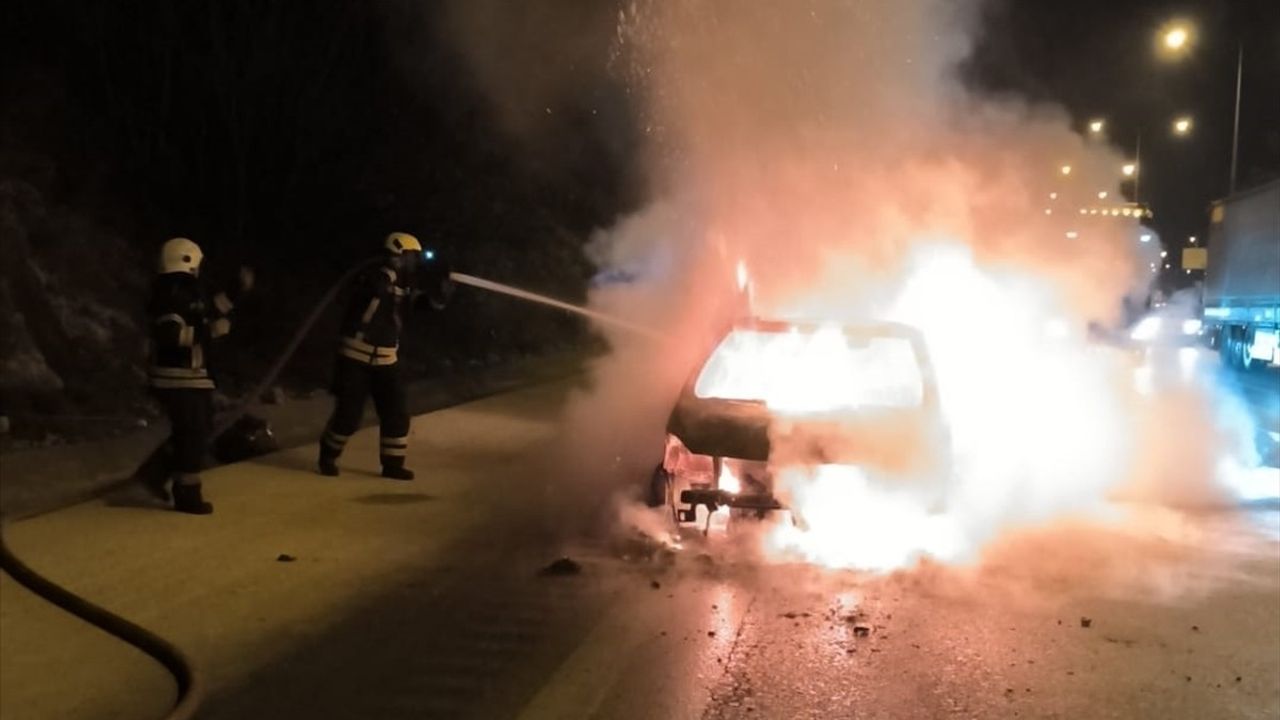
[437,0,1259,556]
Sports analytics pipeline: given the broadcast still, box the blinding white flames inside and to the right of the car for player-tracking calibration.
[711,243,1140,570]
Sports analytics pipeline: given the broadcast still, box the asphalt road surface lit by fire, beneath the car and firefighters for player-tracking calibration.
[0,384,1280,720]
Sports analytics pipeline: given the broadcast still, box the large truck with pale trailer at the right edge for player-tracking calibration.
[1202,179,1280,370]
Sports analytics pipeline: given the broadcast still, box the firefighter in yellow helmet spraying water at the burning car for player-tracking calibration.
[319,232,453,480]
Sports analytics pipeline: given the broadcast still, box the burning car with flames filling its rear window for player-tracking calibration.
[649,319,950,524]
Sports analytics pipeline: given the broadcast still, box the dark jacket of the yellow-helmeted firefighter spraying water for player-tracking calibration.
[338,265,411,365]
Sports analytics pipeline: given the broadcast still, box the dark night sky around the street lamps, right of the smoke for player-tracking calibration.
[969,0,1280,285]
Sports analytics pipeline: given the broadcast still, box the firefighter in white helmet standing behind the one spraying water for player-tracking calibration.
[147,237,253,515]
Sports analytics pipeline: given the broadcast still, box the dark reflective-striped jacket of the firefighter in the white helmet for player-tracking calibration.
[147,273,234,389]
